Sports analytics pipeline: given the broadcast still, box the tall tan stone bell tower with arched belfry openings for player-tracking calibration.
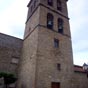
[18,0,73,88]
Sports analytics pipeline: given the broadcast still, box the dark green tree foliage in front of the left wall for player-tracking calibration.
[0,72,17,84]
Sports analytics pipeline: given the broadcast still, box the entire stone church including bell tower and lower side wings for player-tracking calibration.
[0,0,88,88]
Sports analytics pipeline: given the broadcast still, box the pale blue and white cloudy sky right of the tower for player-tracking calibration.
[68,0,88,65]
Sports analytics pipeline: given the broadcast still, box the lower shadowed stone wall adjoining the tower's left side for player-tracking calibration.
[0,33,23,73]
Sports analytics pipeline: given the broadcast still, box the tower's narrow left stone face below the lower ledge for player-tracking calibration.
[17,29,38,88]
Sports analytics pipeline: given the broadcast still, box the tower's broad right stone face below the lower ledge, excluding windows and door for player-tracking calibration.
[36,27,73,88]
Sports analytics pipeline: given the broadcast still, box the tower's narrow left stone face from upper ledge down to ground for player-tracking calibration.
[18,8,40,88]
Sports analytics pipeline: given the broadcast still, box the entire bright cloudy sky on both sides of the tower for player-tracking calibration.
[0,0,88,65]
